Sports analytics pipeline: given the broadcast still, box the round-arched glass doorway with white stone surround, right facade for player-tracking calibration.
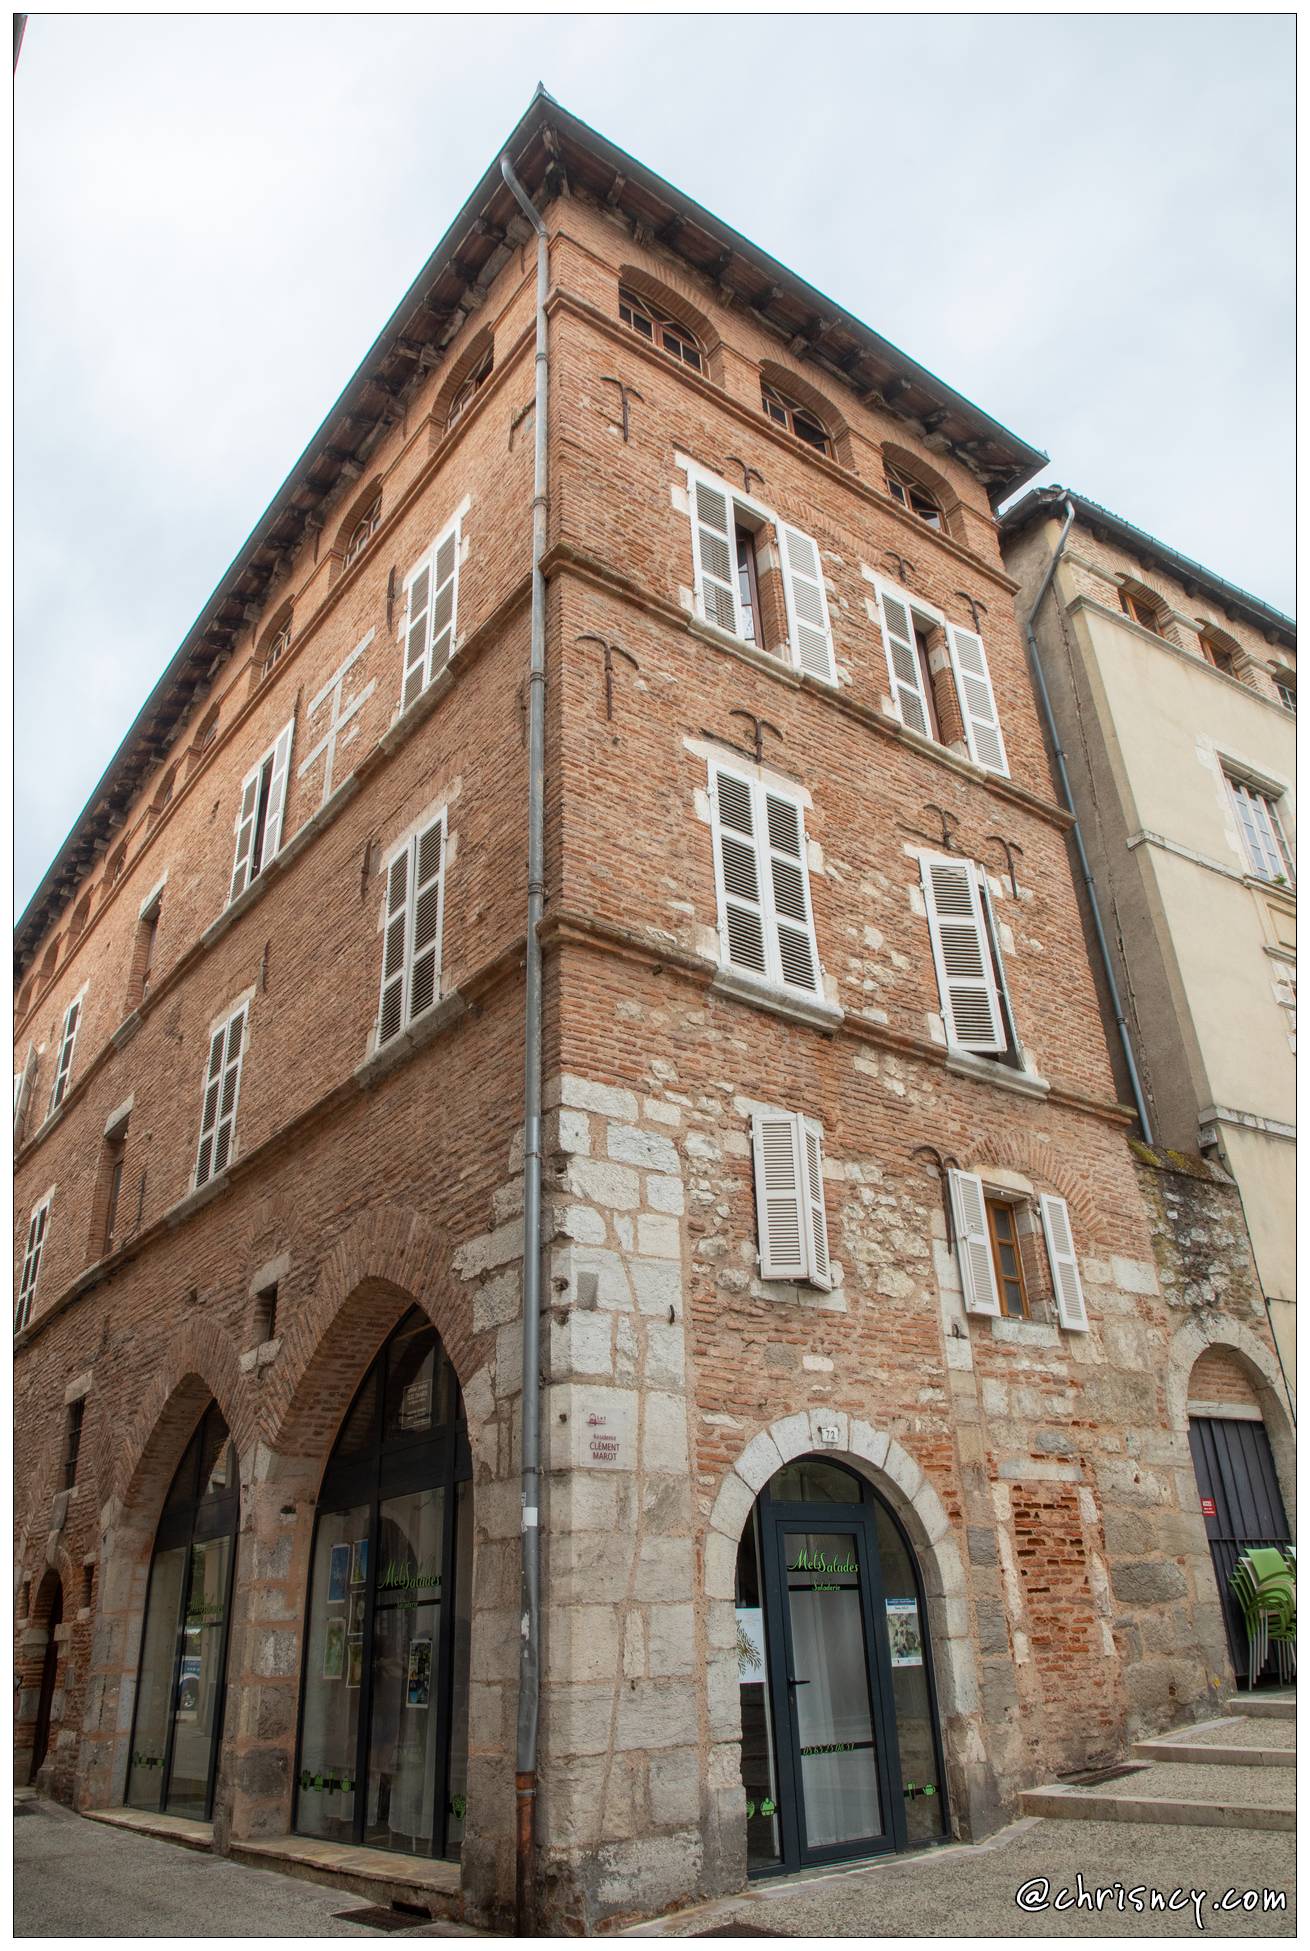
[736,1455,947,1875]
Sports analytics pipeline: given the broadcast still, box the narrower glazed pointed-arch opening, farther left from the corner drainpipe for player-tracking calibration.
[127,1403,240,1822]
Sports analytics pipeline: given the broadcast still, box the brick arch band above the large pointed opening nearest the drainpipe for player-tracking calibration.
[262,1206,476,1457]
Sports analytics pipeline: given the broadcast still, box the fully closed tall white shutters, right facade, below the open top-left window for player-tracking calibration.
[711,767,820,995]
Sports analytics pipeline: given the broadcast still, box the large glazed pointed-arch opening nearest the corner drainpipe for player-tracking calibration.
[295,1307,472,1857]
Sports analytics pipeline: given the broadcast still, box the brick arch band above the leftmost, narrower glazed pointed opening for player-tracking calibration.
[112,1321,258,1514]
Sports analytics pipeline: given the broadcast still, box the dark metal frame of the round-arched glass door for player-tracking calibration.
[752,1457,949,1877]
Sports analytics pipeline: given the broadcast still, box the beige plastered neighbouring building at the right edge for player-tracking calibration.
[1002,488,1296,1389]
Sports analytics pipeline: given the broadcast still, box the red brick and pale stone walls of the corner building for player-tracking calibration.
[16,95,1304,1930]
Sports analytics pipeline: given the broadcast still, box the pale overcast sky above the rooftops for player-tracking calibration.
[16,16,1294,909]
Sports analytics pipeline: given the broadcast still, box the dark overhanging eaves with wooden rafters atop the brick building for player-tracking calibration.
[14,88,1046,972]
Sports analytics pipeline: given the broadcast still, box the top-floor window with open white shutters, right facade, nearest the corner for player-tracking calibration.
[689,474,838,685]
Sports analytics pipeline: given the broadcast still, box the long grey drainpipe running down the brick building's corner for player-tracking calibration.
[500,156,551,1937]
